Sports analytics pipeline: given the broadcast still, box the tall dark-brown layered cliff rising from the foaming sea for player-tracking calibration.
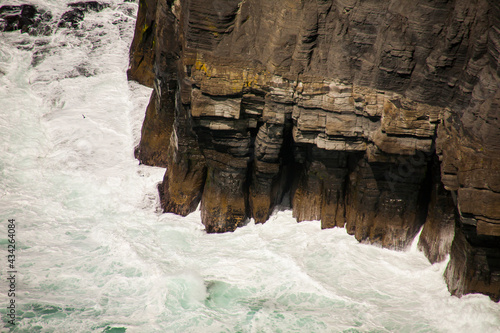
[129,0,500,300]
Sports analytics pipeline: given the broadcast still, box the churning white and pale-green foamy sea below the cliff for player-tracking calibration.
[0,0,500,333]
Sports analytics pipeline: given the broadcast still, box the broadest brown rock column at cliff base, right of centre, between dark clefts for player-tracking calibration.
[346,154,427,249]
